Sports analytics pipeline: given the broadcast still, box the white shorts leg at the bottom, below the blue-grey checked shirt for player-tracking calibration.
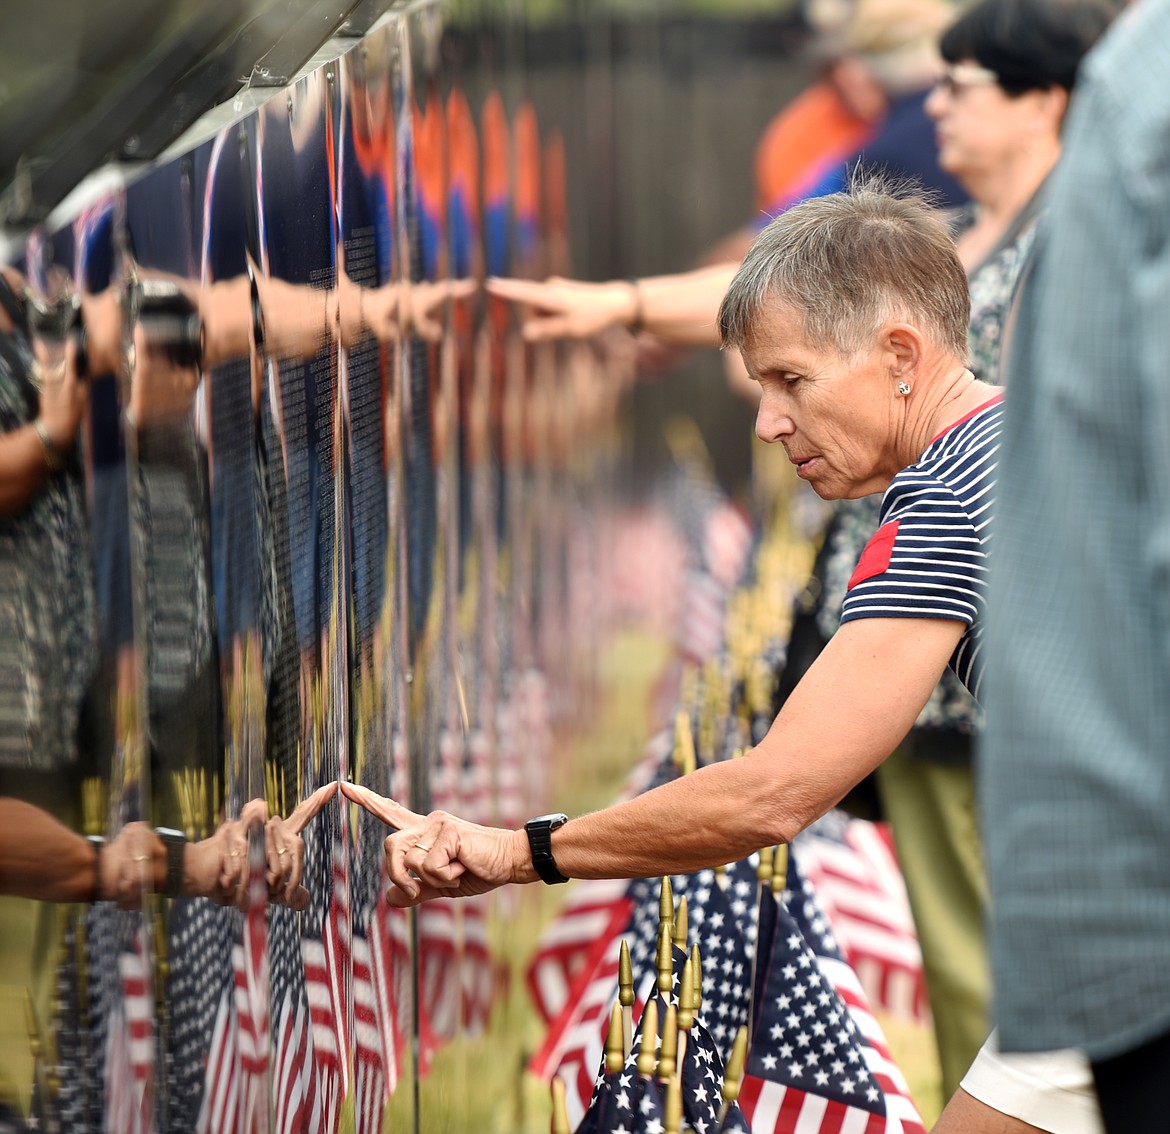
[963,1032,1104,1134]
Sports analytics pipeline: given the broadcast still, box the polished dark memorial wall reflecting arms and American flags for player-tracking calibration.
[0,4,625,1132]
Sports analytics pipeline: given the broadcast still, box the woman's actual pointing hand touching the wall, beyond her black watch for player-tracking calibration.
[342,782,536,908]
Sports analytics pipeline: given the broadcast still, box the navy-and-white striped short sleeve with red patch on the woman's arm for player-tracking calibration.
[841,477,986,626]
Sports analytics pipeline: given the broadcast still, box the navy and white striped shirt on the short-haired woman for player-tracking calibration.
[841,394,1004,697]
